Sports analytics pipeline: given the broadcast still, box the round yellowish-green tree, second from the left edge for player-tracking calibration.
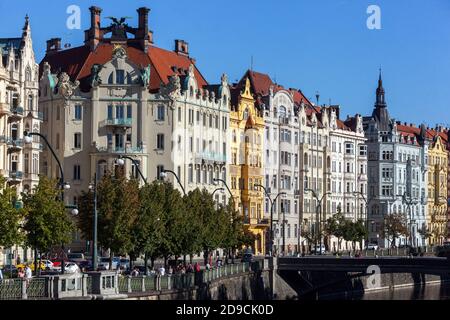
[23,176,74,270]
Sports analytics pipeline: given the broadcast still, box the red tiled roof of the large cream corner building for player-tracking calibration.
[40,43,208,91]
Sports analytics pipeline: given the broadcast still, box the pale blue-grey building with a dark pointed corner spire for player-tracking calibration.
[364,74,428,247]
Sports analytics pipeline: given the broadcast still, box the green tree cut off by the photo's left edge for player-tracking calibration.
[0,177,24,260]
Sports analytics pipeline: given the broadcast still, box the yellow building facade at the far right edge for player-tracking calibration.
[427,132,448,244]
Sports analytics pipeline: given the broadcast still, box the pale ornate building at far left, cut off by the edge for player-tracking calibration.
[0,16,42,264]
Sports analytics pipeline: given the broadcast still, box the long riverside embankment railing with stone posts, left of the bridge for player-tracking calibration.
[0,263,251,300]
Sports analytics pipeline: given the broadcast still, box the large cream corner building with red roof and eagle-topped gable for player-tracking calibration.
[40,7,231,250]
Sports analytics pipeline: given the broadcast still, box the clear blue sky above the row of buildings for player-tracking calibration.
[0,0,450,126]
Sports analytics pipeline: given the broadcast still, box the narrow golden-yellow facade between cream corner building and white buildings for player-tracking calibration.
[230,78,270,255]
